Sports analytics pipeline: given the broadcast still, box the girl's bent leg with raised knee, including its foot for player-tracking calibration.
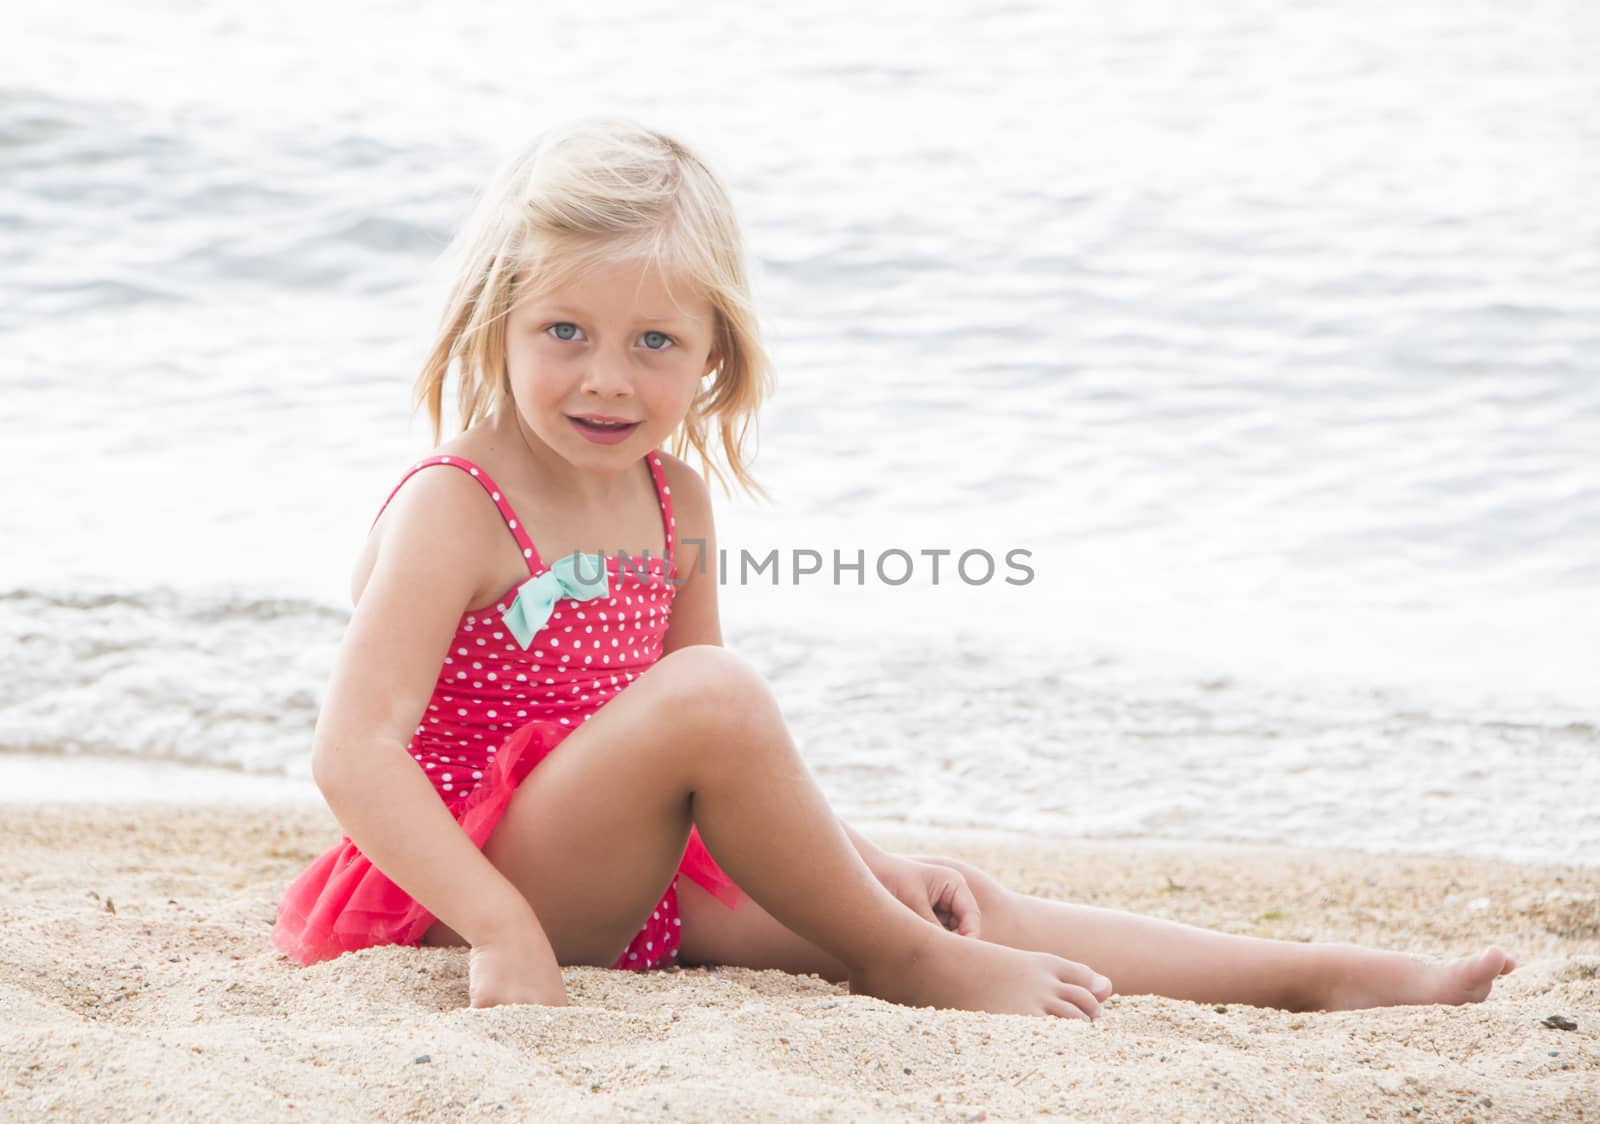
[424,645,1104,1017]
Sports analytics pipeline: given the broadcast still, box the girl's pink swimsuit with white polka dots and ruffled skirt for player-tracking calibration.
[272,452,744,972]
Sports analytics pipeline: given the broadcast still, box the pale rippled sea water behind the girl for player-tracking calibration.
[0,2,1600,861]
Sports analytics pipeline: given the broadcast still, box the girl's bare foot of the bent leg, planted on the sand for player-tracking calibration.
[850,925,1110,1018]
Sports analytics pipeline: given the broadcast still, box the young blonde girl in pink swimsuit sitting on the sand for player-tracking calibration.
[274,120,1512,1018]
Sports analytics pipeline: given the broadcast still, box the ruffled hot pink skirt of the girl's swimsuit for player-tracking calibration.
[272,721,746,972]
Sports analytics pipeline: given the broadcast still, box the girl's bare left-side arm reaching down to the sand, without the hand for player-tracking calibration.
[312,469,560,960]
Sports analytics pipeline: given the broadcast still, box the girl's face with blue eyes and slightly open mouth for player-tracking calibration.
[506,263,720,471]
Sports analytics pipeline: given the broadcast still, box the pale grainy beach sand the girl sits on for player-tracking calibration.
[0,804,1600,1121]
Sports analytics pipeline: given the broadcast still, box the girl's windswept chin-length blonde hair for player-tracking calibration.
[414,117,773,496]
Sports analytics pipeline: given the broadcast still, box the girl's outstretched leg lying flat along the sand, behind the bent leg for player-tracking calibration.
[678,838,1514,1010]
